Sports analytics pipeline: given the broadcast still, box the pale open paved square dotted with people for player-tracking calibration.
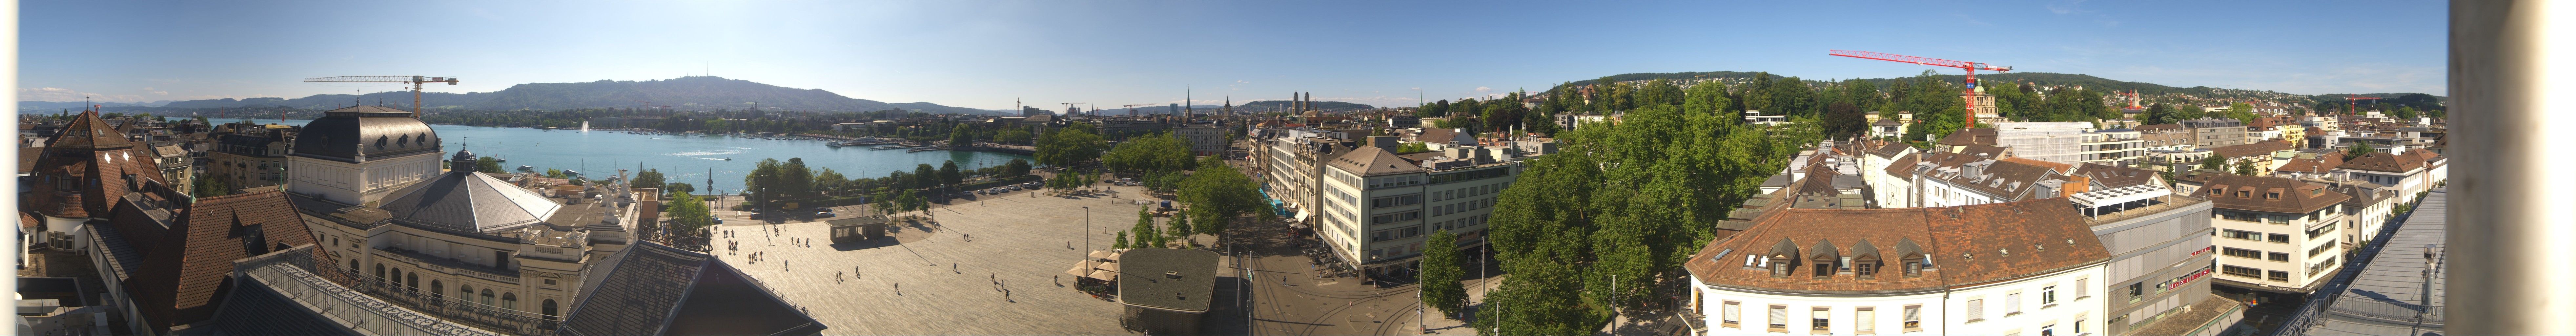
[716,186,1180,333]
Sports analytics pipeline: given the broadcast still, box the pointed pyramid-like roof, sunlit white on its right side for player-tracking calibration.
[379,171,564,233]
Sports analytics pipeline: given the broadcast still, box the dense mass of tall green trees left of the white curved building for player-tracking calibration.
[1473,85,1824,333]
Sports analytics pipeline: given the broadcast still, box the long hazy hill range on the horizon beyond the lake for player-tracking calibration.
[138,75,999,114]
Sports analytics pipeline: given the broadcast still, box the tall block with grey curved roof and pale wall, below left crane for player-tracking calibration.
[286,106,443,204]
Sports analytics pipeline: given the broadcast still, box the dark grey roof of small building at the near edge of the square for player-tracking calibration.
[1118,248,1216,313]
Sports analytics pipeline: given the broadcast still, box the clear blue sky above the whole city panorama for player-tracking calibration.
[18,0,2447,109]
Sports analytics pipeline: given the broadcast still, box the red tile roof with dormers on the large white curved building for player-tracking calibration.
[1682,199,2110,292]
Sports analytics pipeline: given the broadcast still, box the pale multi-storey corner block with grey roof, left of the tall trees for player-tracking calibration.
[1316,137,1520,271]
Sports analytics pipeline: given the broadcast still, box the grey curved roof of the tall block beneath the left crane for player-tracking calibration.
[296,106,440,163]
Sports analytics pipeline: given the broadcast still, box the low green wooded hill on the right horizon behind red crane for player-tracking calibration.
[1561,73,2450,109]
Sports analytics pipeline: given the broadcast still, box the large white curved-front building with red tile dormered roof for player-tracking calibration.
[1685,199,2110,336]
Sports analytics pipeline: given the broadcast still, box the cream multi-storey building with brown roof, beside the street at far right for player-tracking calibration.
[2195,176,2352,295]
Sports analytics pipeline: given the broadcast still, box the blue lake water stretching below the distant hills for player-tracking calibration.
[254,119,1028,194]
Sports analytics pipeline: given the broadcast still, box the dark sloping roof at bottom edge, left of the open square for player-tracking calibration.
[562,241,824,336]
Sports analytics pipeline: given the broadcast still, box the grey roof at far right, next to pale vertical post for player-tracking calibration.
[2305,189,2450,336]
